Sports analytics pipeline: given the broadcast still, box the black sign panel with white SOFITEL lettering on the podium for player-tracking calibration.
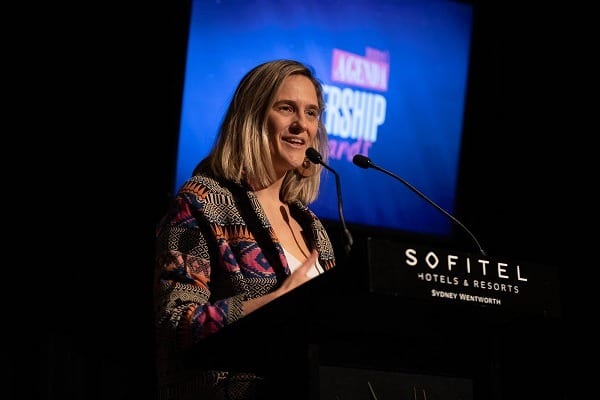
[368,238,559,315]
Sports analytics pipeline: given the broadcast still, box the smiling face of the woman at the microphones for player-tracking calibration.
[267,75,319,176]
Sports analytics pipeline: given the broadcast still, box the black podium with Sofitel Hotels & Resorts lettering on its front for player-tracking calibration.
[188,238,561,400]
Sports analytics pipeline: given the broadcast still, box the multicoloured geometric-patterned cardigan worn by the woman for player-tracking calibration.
[154,176,335,400]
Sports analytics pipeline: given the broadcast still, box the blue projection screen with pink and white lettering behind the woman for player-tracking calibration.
[175,0,473,236]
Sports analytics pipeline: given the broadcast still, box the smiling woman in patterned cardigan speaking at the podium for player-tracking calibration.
[155,60,335,400]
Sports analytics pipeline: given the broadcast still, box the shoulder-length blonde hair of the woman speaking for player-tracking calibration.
[194,60,328,204]
